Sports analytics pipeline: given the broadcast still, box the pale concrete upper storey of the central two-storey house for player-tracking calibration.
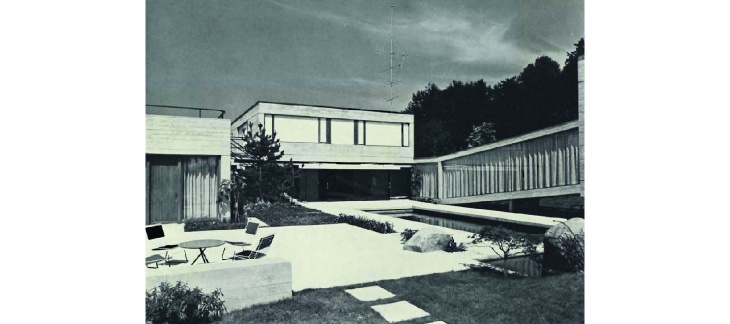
[230,102,414,166]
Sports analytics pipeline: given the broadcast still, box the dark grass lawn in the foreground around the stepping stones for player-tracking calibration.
[221,269,584,324]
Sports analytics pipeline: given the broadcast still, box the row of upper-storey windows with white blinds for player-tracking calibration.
[239,114,410,146]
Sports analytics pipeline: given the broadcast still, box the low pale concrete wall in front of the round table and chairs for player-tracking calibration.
[146,258,292,312]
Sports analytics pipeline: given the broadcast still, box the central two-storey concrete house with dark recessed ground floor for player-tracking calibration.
[230,101,413,201]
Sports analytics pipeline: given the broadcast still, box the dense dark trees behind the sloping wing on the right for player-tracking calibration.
[405,38,585,157]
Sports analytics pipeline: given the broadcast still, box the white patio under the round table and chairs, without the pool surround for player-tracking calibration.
[146,224,486,291]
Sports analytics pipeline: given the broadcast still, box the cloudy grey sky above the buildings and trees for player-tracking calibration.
[146,0,584,119]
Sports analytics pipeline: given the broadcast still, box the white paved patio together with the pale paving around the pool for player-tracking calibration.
[146,200,555,291]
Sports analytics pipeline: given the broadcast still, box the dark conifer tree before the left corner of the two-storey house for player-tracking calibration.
[237,124,297,202]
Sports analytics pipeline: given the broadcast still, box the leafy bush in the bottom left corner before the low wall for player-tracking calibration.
[145,281,226,324]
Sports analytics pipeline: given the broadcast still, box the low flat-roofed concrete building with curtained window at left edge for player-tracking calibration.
[145,110,231,224]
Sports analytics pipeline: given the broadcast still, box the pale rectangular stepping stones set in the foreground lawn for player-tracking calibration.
[345,286,446,324]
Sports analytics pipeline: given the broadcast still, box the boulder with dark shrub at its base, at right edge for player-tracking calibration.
[543,218,585,272]
